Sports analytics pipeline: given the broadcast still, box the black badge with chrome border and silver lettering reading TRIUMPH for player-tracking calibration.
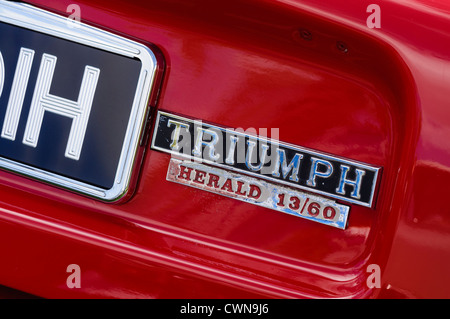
[152,111,381,207]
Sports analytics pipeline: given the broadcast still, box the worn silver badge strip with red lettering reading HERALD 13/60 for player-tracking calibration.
[167,157,350,229]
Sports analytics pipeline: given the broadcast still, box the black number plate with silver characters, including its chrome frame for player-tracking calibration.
[0,1,160,201]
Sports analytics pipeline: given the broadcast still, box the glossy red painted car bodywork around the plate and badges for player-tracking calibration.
[0,0,450,298]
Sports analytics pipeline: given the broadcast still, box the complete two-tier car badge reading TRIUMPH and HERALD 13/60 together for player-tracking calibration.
[152,111,381,229]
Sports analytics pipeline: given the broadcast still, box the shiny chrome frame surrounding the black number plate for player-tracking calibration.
[0,0,158,201]
